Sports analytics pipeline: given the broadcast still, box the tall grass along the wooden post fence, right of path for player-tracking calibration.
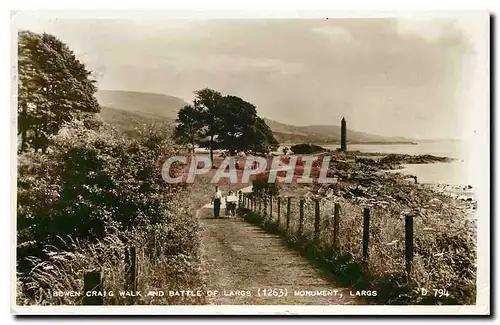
[241,181,476,304]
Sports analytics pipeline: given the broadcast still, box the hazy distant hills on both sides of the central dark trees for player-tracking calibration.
[96,90,411,143]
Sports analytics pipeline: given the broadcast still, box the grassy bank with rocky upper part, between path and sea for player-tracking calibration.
[241,152,477,305]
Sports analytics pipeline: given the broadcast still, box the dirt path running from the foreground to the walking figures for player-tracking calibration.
[198,200,357,305]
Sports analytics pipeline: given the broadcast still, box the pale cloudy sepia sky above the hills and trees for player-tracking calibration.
[13,12,489,139]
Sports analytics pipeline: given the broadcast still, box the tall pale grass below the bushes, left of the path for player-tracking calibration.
[17,221,204,305]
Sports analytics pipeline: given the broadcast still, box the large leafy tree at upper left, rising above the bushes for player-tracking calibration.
[18,31,100,151]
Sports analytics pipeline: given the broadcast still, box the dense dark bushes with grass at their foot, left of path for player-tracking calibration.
[17,121,203,304]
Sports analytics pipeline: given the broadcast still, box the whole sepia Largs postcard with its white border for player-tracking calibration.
[11,11,491,315]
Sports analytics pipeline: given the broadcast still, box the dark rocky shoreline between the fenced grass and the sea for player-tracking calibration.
[282,151,477,219]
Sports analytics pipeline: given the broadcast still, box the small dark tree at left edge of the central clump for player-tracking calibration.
[174,105,203,153]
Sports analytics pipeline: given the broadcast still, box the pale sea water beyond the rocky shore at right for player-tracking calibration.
[324,140,475,185]
